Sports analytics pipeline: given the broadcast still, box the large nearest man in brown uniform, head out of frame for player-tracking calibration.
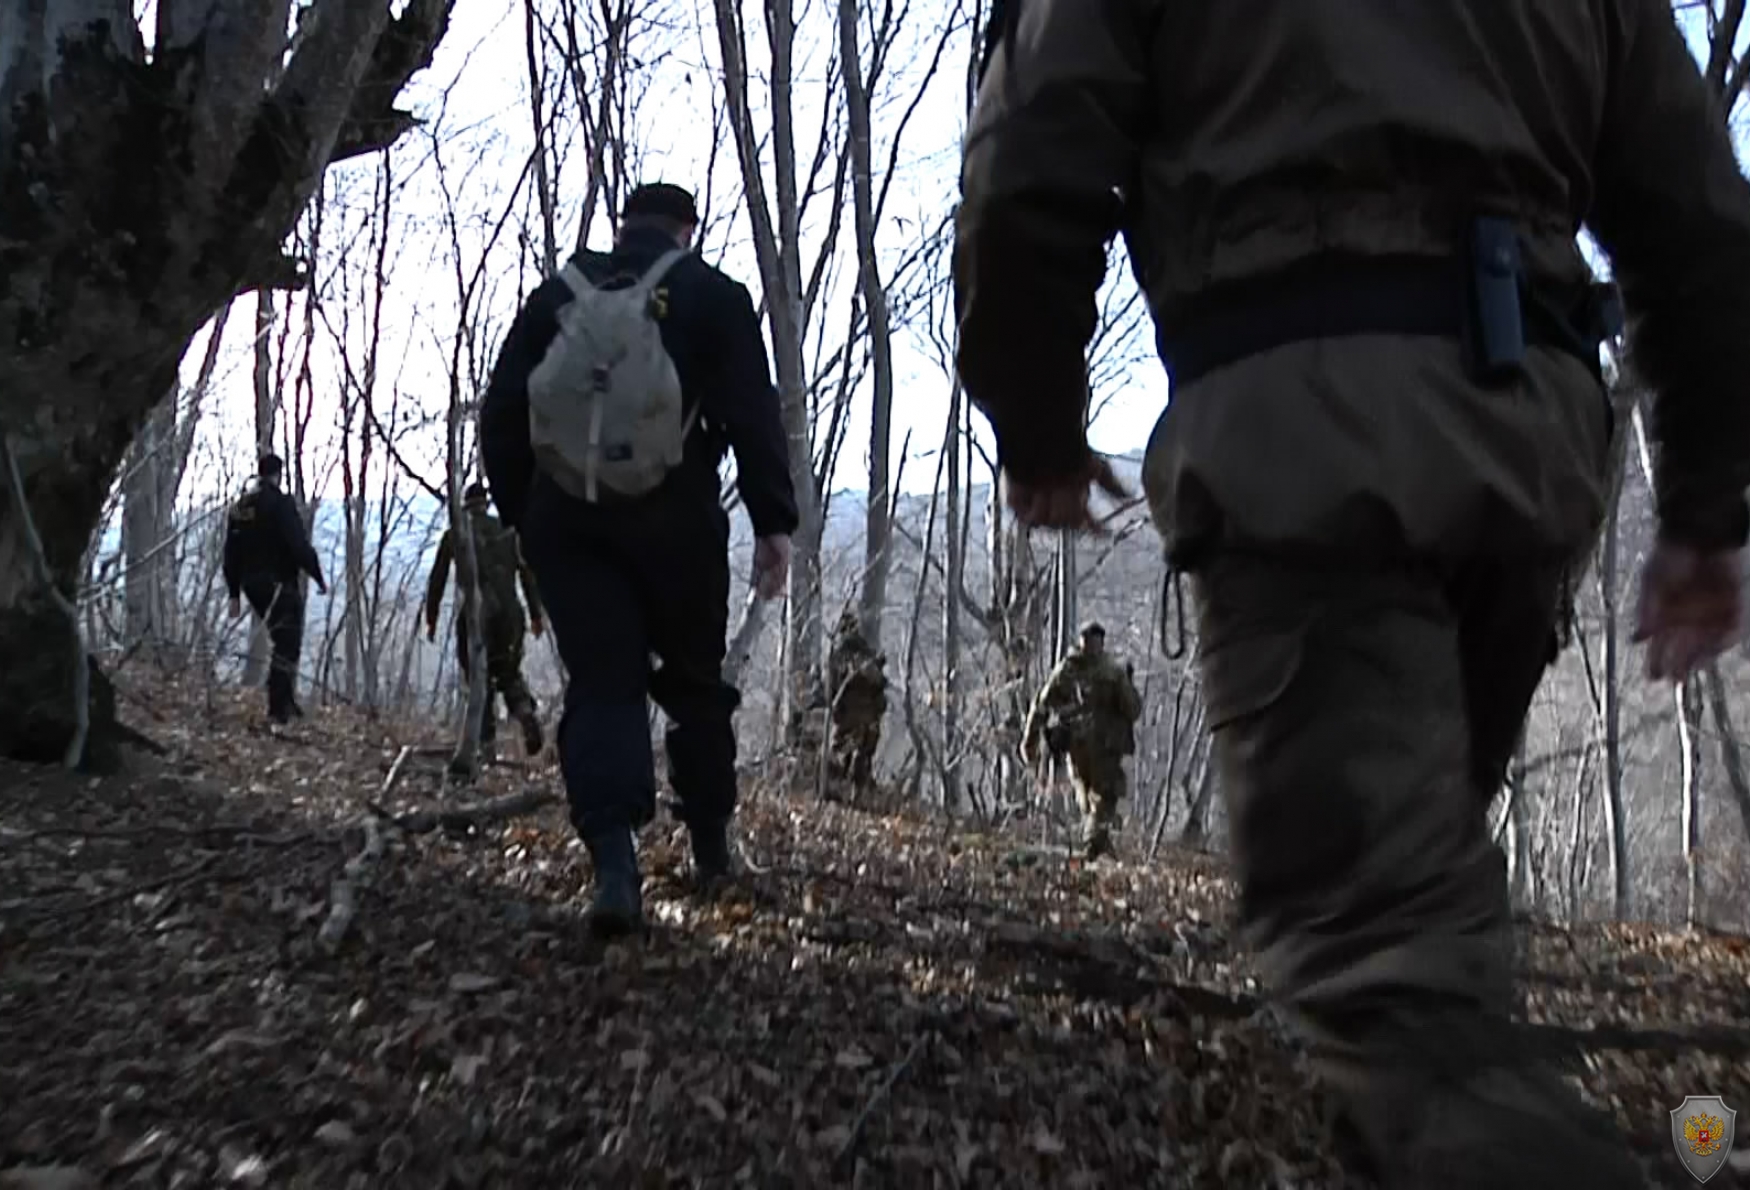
[954,0,1750,1190]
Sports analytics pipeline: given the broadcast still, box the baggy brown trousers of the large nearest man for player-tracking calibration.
[1195,555,1636,1190]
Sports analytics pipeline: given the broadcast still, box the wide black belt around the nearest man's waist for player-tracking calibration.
[1155,257,1622,385]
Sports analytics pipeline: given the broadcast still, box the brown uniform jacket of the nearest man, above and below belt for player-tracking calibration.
[954,0,1750,557]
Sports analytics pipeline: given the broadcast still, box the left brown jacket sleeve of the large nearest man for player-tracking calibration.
[954,0,1153,483]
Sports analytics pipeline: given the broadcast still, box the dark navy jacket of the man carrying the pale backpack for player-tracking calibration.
[480,228,796,537]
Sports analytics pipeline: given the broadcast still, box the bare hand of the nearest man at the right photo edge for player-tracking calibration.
[1635,541,1743,681]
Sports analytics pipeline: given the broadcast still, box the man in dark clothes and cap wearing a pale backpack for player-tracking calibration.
[480,184,796,933]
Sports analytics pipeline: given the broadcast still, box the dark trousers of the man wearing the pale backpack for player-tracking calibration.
[520,476,740,840]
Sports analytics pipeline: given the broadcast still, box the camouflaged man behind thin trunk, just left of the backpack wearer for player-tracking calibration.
[425,483,546,756]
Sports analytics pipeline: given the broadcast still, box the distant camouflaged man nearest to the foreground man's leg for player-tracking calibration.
[1020,623,1143,859]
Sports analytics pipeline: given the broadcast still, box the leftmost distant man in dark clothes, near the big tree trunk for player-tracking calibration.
[222,455,327,725]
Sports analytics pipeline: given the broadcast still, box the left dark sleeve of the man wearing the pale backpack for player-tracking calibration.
[480,278,571,529]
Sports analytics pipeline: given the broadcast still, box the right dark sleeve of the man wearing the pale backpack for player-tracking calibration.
[700,282,798,537]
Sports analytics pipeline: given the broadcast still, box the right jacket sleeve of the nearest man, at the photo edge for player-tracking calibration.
[1587,0,1750,550]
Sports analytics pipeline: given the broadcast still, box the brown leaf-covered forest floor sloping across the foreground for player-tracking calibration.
[0,690,1750,1190]
